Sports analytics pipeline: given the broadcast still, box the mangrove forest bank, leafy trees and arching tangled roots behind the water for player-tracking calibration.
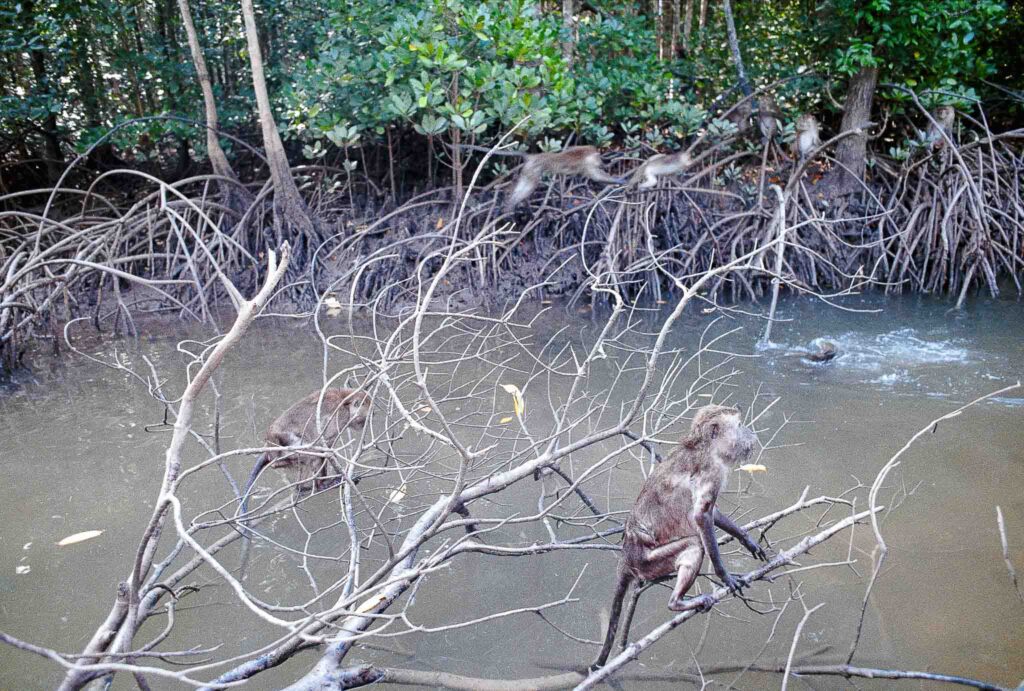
[0,0,1024,369]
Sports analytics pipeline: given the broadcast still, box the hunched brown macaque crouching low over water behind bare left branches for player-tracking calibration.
[239,389,371,522]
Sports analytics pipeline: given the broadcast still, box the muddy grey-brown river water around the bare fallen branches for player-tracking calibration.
[0,296,1024,689]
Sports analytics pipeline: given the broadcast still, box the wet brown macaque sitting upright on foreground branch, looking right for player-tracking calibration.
[592,405,768,668]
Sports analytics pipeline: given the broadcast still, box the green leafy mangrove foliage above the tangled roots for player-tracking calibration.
[0,0,1024,176]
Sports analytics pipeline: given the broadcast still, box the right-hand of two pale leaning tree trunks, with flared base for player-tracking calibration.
[242,0,317,243]
